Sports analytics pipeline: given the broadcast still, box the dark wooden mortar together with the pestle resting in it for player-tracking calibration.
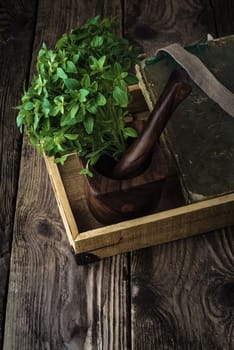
[85,71,191,224]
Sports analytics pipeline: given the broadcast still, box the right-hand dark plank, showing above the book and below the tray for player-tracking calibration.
[125,0,234,350]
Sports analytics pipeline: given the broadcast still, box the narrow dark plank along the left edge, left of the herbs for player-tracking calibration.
[0,0,36,348]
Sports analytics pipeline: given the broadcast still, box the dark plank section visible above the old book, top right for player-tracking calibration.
[124,0,215,55]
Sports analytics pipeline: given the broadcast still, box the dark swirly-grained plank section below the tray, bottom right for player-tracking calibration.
[131,227,234,350]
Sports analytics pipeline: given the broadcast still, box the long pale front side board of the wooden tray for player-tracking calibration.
[75,194,234,257]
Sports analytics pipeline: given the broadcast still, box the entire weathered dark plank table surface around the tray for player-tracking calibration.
[0,0,234,350]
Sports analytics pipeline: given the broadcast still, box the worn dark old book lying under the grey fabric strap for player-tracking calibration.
[139,36,234,202]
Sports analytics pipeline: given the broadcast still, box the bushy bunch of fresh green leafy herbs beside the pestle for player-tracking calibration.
[17,16,138,175]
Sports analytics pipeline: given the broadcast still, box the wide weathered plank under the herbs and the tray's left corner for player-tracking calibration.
[4,0,130,350]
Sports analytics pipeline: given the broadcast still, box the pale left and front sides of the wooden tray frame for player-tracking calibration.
[44,87,234,264]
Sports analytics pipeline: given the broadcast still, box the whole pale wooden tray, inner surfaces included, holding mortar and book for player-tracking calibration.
[44,86,234,264]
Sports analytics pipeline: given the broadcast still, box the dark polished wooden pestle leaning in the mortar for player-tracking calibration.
[112,70,191,180]
